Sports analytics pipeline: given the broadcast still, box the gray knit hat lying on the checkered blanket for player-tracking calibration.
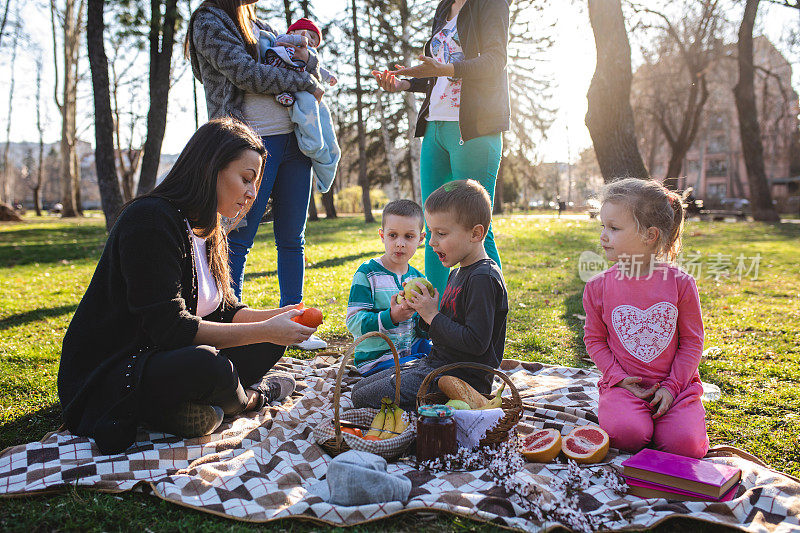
[308,450,411,506]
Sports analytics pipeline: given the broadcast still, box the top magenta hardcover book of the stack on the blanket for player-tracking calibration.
[622,448,742,499]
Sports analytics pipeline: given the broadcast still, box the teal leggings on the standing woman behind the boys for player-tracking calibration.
[419,120,503,295]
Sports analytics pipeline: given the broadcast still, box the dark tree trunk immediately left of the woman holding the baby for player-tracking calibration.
[137,0,178,195]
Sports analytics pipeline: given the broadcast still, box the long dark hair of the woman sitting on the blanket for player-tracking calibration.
[146,117,267,305]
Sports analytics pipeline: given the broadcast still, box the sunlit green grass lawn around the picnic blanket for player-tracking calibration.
[0,211,800,531]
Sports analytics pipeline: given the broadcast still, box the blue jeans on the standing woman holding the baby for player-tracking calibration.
[228,133,311,306]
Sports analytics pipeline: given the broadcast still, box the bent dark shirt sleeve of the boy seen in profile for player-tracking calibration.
[428,275,502,362]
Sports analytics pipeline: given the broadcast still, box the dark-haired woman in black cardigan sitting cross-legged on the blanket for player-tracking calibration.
[58,118,315,453]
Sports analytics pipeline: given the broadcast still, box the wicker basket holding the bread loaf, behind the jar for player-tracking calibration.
[417,362,522,446]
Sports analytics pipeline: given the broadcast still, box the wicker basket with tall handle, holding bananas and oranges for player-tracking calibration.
[314,331,416,460]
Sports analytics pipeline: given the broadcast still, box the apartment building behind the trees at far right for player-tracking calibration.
[632,36,800,212]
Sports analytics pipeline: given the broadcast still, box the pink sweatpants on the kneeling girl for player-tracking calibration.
[597,383,708,459]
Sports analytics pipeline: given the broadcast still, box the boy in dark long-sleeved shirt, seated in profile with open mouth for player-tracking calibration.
[352,180,508,409]
